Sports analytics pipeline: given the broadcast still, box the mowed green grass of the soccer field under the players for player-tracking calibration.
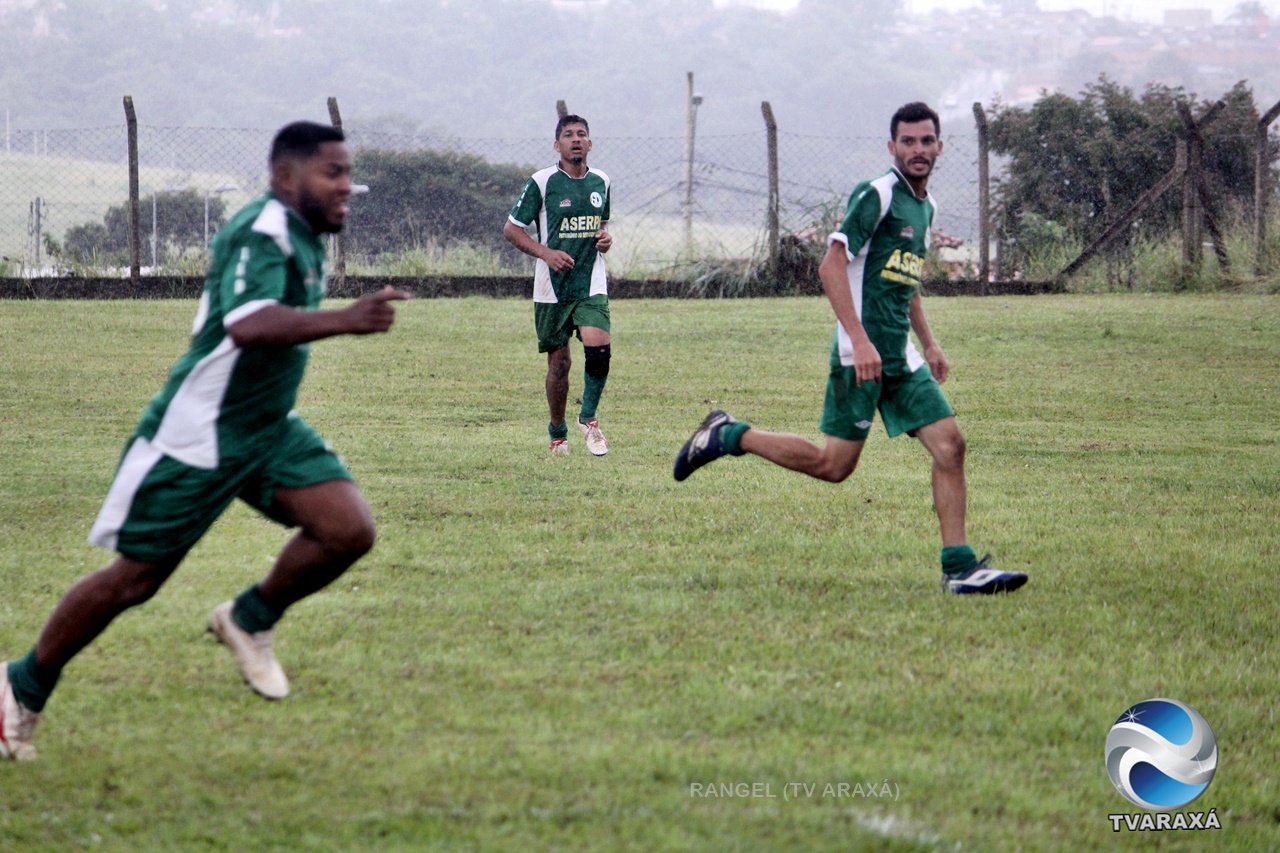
[0,290,1280,850]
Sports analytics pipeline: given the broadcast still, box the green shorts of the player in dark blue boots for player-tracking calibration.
[818,365,955,442]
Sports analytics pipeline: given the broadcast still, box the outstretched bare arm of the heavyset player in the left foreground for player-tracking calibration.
[227,284,410,347]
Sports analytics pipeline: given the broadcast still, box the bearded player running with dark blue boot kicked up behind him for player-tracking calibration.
[675,102,1027,593]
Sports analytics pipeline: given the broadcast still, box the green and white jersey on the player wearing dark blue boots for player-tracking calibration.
[828,168,937,377]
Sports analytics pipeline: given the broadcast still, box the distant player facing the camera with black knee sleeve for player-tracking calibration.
[502,115,613,456]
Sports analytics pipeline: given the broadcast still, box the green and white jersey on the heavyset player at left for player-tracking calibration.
[137,195,325,469]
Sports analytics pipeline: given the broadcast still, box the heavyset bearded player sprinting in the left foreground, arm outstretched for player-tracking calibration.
[0,122,408,760]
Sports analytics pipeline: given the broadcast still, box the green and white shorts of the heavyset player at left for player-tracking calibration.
[90,415,352,562]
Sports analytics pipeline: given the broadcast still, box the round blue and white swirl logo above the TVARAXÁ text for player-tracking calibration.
[1107,699,1217,812]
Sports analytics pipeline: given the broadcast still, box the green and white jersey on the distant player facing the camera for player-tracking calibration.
[511,164,609,302]
